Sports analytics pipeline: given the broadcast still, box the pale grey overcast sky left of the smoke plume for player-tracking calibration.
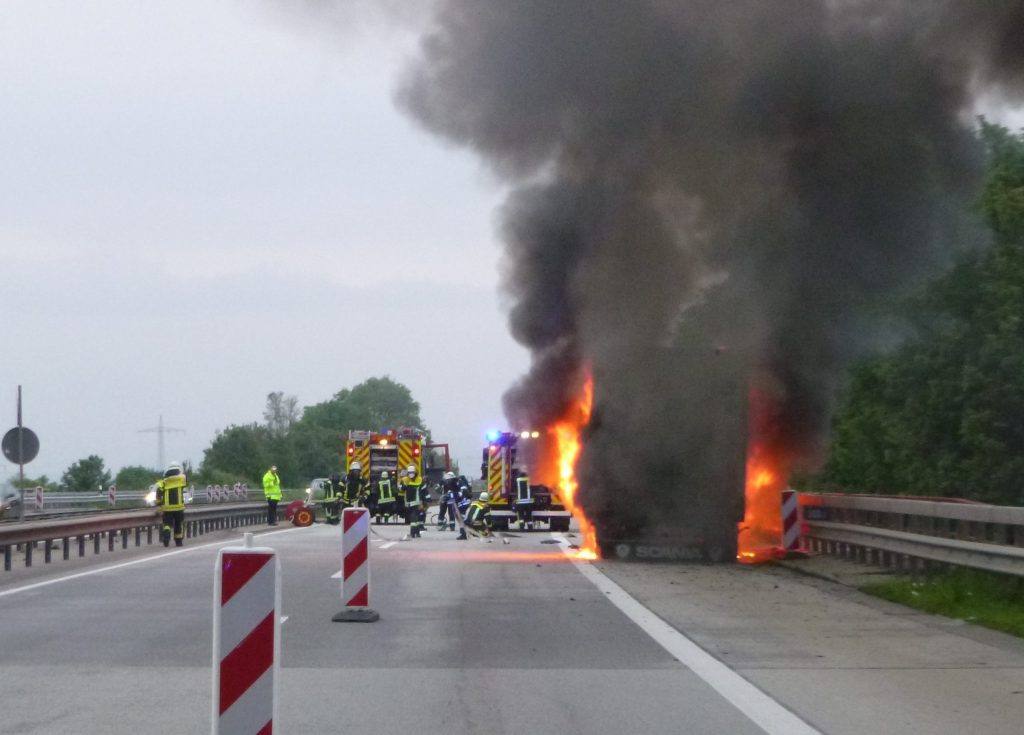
[0,0,527,477]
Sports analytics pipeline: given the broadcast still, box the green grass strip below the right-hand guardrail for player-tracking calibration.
[860,569,1024,638]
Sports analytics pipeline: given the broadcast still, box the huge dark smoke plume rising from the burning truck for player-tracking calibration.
[399,0,1024,536]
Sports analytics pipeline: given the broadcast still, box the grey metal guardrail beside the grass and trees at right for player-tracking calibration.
[800,493,1024,576]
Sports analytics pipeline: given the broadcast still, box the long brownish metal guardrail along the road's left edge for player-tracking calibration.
[0,503,285,571]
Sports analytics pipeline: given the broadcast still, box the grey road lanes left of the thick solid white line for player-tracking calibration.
[0,525,762,735]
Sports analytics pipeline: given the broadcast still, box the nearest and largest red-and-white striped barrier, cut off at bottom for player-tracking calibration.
[213,533,281,735]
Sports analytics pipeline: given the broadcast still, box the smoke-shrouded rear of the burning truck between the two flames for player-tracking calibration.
[578,335,750,562]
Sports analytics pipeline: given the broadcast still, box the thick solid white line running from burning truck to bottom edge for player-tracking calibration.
[551,533,821,735]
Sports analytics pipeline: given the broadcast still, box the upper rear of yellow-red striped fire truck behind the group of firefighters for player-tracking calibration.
[345,427,452,482]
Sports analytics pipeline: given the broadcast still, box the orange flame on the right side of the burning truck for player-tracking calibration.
[736,391,790,564]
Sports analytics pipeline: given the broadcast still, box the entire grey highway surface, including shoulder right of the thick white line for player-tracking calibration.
[0,524,1024,735]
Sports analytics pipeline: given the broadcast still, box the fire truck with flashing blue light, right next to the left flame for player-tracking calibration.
[480,431,571,531]
